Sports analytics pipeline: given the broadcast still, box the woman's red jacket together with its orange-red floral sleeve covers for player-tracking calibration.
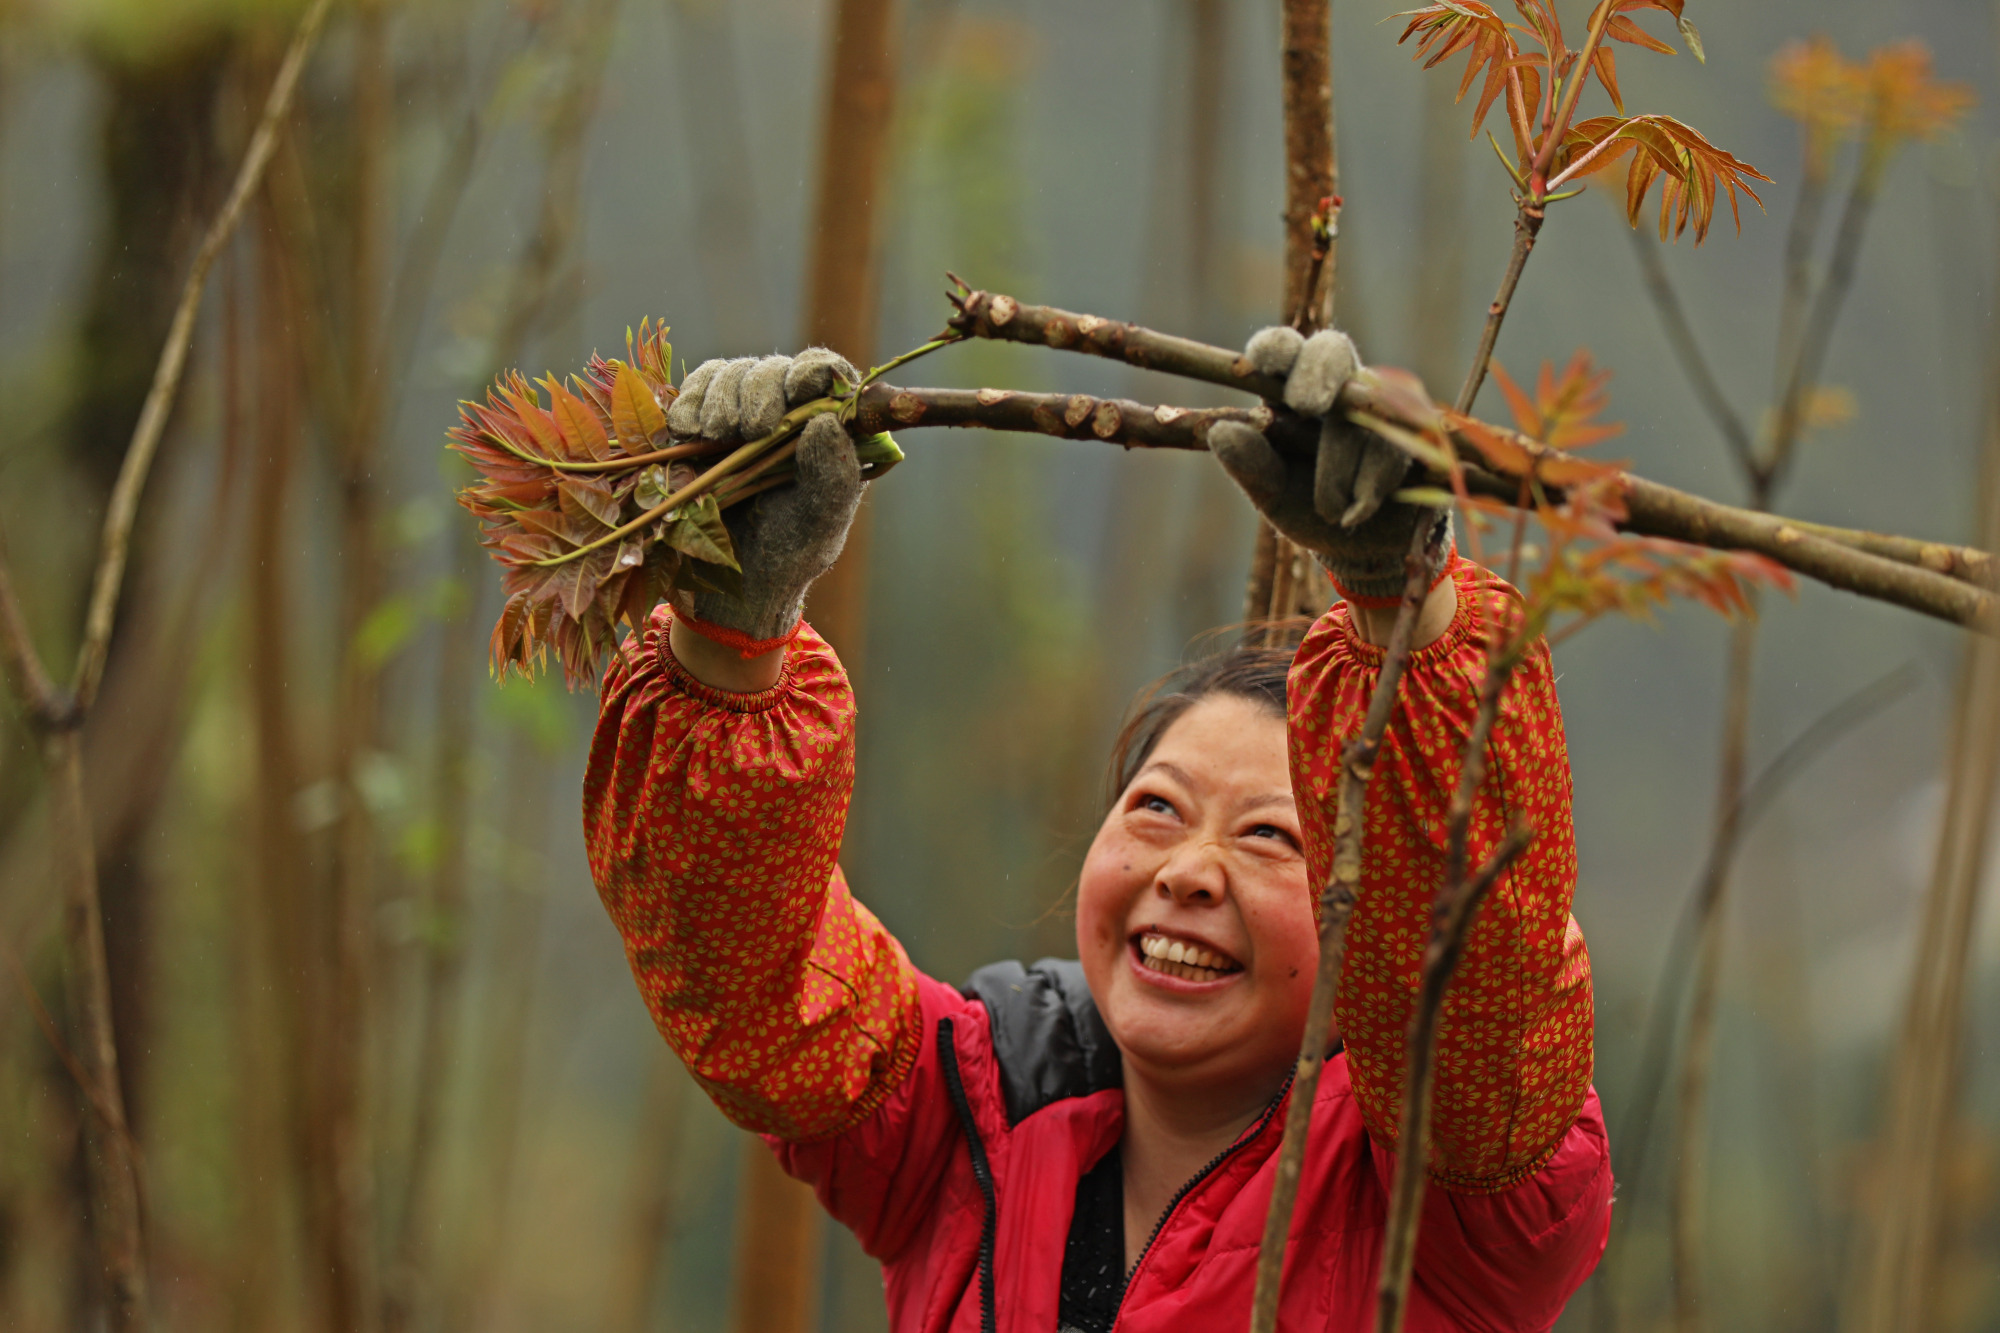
[584,562,1612,1333]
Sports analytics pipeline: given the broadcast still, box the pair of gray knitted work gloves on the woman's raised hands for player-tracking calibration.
[666,328,1450,646]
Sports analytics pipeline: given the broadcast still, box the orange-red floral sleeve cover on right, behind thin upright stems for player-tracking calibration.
[1288,558,1592,1193]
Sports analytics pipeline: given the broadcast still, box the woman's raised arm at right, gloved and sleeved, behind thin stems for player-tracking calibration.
[1210,330,1612,1331]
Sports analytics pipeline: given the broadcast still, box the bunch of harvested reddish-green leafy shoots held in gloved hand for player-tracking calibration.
[448,320,902,689]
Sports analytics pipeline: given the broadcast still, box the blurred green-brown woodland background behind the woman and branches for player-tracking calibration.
[0,0,2000,1333]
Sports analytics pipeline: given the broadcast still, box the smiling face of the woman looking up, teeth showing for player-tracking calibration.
[1076,695,1318,1101]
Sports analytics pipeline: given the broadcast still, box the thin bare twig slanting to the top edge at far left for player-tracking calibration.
[70,0,332,713]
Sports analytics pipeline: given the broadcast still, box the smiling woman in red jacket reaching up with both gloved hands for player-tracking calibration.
[584,330,1612,1333]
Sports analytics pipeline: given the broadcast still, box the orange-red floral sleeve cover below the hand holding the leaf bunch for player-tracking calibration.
[584,606,922,1141]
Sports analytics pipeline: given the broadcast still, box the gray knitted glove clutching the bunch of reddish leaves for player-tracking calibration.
[666,346,864,640]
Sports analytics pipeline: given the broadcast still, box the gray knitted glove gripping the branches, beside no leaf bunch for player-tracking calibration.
[1208,326,1450,600]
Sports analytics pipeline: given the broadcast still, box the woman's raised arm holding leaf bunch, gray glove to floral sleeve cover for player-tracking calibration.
[584,350,920,1141]
